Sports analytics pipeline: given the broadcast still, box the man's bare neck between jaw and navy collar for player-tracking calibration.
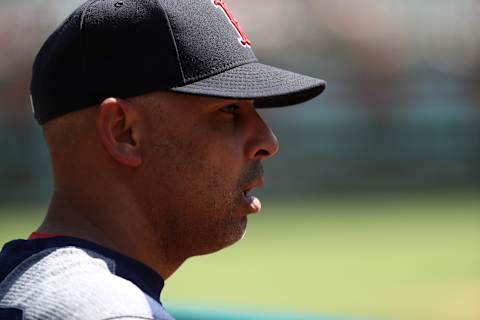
[37,189,184,279]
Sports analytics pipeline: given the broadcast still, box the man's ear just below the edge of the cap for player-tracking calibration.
[96,98,142,167]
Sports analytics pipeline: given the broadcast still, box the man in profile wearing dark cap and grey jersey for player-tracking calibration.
[0,0,325,320]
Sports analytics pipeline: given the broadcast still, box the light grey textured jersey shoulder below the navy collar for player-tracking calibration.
[0,246,172,319]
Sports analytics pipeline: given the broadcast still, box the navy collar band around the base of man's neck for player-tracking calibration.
[0,236,164,300]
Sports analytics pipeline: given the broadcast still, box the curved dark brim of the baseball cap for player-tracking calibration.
[170,62,326,108]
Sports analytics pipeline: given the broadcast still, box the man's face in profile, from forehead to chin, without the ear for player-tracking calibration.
[133,92,278,258]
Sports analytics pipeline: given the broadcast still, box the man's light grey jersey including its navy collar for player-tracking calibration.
[0,237,173,320]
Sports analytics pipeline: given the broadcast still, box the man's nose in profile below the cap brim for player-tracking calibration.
[246,112,279,160]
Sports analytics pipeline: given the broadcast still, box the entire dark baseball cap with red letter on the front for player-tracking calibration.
[30,0,325,124]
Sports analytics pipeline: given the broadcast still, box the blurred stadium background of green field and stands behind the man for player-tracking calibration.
[0,0,480,320]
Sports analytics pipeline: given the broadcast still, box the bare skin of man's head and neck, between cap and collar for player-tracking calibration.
[37,92,278,279]
